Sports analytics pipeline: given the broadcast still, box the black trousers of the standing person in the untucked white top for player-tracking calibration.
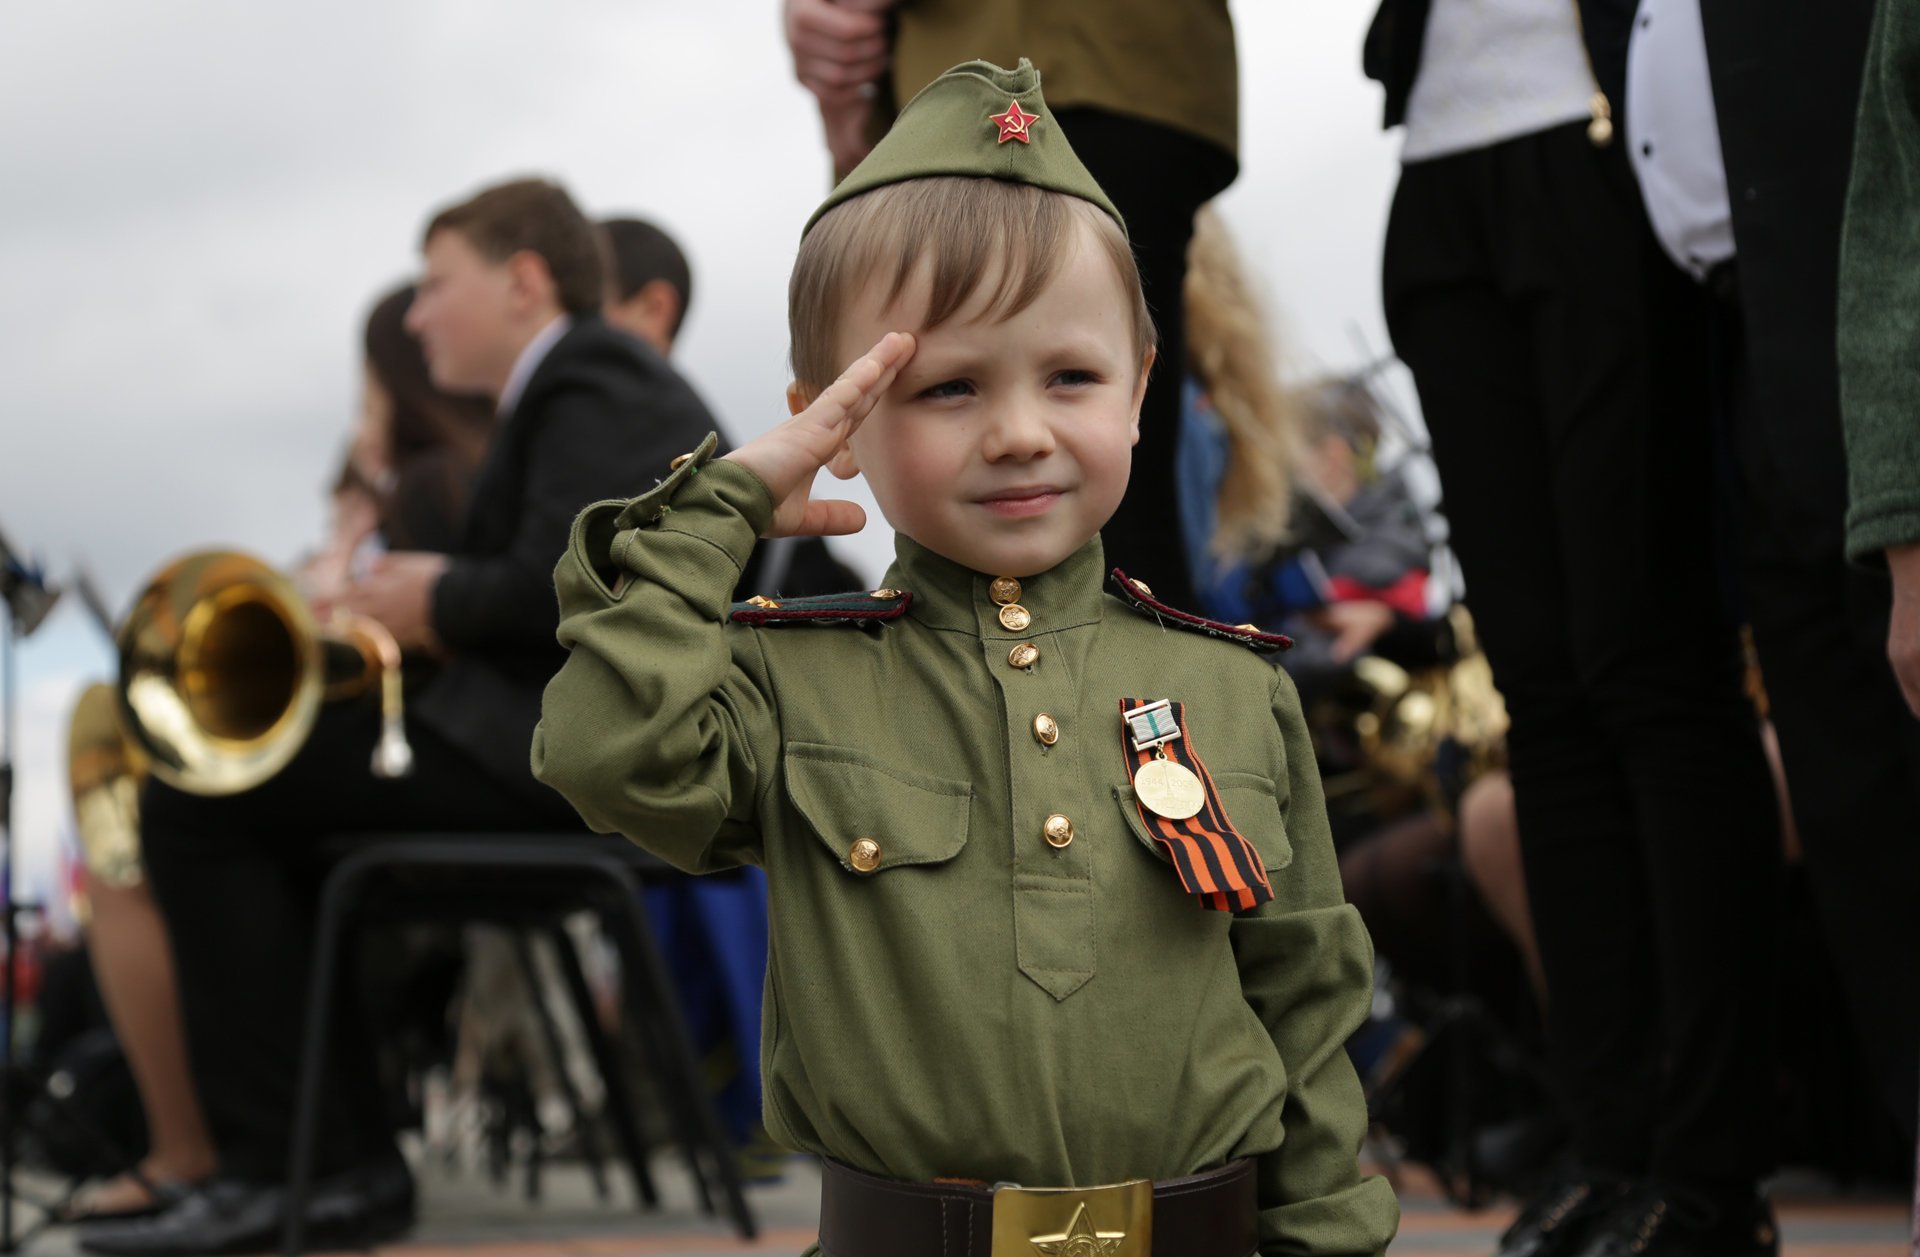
[1384,125,1780,1186]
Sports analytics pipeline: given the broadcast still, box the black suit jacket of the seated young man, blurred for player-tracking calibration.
[413,317,716,818]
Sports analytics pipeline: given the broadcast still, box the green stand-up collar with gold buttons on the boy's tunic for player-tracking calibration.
[885,534,1106,641]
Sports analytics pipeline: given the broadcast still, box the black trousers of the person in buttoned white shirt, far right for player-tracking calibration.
[1718,265,1920,1146]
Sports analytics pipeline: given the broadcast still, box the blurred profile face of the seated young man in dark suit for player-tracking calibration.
[407,228,518,397]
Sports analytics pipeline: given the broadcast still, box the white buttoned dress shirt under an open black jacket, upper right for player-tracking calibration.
[1626,0,1734,280]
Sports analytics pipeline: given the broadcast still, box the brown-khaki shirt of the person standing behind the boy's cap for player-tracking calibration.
[893,0,1240,155]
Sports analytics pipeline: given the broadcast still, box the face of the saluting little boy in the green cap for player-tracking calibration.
[833,223,1152,576]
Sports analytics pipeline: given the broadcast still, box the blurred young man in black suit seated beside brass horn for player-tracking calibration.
[83,180,714,1253]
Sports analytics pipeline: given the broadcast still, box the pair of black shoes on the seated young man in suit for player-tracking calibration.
[79,1165,413,1257]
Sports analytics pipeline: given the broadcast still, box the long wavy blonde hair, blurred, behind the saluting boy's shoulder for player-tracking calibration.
[1185,207,1298,562]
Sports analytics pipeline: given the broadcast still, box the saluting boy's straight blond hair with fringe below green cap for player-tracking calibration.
[787,175,1158,395]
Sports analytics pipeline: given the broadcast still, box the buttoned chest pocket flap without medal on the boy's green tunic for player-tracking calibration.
[785,743,973,875]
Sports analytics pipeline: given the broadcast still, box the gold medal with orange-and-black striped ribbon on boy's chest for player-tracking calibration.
[1119,699,1273,912]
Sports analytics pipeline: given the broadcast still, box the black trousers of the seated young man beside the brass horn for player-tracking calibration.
[140,702,580,1184]
